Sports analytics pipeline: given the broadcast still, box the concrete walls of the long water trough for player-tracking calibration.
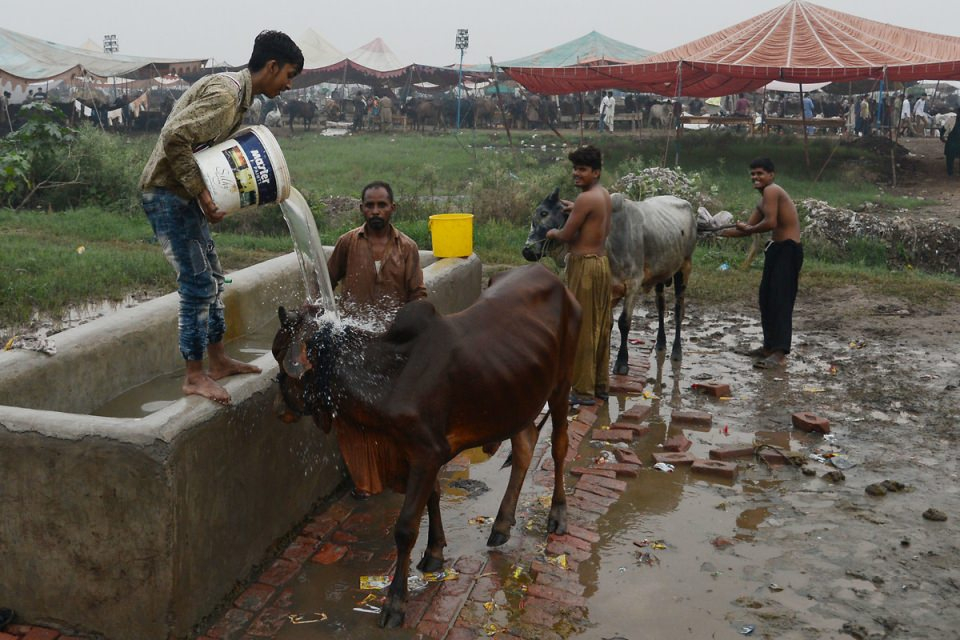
[0,249,481,640]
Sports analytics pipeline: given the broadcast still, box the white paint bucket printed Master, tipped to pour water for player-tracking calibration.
[193,125,290,213]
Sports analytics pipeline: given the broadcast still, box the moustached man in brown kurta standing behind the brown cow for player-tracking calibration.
[327,181,427,499]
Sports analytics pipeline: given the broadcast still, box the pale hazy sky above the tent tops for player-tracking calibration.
[0,0,960,65]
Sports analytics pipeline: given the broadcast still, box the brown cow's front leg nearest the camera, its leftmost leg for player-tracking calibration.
[380,461,440,628]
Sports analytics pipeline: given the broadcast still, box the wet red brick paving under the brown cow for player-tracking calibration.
[0,347,650,640]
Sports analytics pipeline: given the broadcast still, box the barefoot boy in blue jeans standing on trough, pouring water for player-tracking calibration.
[140,31,303,404]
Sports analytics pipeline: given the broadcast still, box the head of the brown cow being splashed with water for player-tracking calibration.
[272,305,333,431]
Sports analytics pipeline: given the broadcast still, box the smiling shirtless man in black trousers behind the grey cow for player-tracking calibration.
[719,158,803,369]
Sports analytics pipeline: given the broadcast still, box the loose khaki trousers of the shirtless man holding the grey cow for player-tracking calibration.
[566,254,613,396]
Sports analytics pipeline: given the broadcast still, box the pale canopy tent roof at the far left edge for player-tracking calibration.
[0,28,206,87]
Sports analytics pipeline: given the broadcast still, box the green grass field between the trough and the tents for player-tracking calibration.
[0,131,960,340]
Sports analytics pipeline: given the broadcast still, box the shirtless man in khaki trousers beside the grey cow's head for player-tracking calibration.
[547,145,613,405]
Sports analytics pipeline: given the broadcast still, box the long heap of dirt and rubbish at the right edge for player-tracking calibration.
[798,198,960,275]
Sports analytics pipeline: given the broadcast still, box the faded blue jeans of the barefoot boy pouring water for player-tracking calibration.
[141,188,226,360]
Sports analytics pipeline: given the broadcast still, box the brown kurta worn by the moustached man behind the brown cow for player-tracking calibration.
[327,225,427,493]
